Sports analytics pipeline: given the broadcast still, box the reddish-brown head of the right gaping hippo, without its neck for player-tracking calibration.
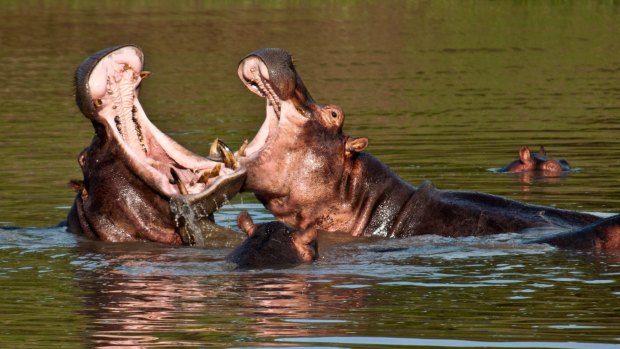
[238,48,368,229]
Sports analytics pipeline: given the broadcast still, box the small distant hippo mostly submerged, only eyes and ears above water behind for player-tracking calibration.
[497,146,571,176]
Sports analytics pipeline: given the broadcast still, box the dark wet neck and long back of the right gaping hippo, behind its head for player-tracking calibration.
[340,153,600,237]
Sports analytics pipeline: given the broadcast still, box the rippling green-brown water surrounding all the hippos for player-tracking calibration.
[0,0,620,348]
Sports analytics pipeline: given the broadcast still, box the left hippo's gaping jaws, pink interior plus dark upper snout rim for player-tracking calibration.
[75,45,245,198]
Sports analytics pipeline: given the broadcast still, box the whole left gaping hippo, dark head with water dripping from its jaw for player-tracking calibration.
[67,45,246,245]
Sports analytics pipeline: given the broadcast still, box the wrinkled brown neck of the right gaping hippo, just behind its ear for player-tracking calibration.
[339,153,416,236]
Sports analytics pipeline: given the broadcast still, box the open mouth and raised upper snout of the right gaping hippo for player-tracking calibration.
[237,48,316,164]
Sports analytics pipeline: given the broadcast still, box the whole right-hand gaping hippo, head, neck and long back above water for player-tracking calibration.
[238,49,620,260]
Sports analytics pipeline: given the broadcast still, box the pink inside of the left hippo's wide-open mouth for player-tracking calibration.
[88,46,234,196]
